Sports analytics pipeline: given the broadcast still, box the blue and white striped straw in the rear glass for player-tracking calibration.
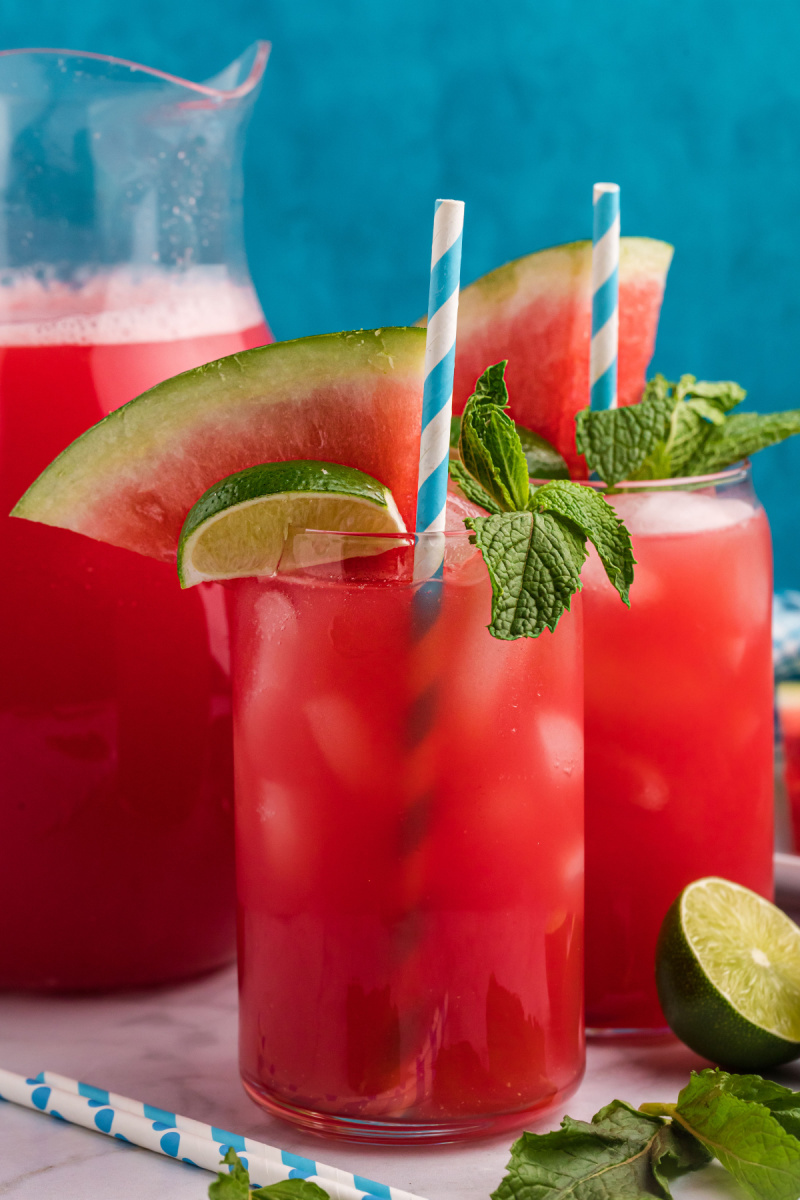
[589,184,619,410]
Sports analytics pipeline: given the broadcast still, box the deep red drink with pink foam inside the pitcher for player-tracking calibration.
[0,271,270,988]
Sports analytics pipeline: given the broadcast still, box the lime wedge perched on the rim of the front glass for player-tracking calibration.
[178,460,405,588]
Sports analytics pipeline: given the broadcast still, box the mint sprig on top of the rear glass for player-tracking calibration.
[576,374,800,486]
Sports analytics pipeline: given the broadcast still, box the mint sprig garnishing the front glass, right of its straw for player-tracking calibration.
[450,361,633,641]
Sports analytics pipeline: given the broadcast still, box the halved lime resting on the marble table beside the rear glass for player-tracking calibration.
[656,877,800,1072]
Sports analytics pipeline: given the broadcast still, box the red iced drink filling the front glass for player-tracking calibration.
[230,538,583,1140]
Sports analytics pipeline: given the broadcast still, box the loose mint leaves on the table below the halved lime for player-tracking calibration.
[492,1068,800,1200]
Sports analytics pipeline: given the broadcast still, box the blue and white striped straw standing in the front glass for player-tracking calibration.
[414,200,464,580]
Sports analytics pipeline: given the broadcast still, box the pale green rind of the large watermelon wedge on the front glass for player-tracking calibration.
[12,326,425,556]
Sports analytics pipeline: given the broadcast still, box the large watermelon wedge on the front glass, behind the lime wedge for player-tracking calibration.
[12,329,425,562]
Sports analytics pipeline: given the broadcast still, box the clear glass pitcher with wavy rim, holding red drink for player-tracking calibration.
[0,42,271,989]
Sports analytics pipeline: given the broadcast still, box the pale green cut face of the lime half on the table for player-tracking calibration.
[681,878,800,1042]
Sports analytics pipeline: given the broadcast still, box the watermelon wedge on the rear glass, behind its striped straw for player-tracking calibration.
[453,238,673,478]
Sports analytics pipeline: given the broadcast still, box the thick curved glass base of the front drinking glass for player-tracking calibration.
[242,1068,583,1146]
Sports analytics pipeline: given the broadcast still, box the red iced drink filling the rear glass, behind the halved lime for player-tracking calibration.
[583,490,772,1030]
